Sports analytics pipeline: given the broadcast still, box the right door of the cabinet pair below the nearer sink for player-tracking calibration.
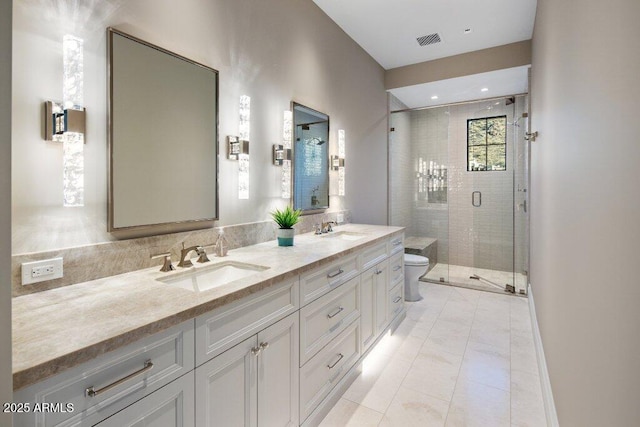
[257,313,300,427]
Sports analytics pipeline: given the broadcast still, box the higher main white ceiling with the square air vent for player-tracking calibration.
[313,0,536,70]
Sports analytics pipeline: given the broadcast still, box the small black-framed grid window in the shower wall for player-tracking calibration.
[467,116,507,172]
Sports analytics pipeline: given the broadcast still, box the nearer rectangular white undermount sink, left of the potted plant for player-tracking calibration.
[157,261,269,292]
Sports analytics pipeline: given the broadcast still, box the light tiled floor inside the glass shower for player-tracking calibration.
[421,263,527,293]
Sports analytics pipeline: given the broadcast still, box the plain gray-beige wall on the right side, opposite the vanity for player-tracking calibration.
[531,0,640,427]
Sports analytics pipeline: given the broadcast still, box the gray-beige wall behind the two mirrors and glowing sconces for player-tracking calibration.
[12,0,387,254]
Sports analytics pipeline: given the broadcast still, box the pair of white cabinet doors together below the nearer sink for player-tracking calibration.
[195,313,299,427]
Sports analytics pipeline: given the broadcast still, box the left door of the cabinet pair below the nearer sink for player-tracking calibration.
[196,335,258,427]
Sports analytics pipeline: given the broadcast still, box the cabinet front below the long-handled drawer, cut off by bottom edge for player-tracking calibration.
[96,371,194,427]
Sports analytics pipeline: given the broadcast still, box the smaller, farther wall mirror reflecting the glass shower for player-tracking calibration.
[293,102,329,212]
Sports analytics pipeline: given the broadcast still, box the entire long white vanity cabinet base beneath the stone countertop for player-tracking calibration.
[14,229,404,427]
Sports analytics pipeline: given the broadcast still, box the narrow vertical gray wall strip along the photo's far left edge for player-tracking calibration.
[0,0,13,426]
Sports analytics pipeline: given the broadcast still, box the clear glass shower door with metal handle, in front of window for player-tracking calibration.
[462,97,528,293]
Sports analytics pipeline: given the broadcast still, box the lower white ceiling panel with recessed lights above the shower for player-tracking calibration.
[389,66,529,108]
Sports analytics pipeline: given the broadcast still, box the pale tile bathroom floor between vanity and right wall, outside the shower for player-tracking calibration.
[321,283,546,427]
